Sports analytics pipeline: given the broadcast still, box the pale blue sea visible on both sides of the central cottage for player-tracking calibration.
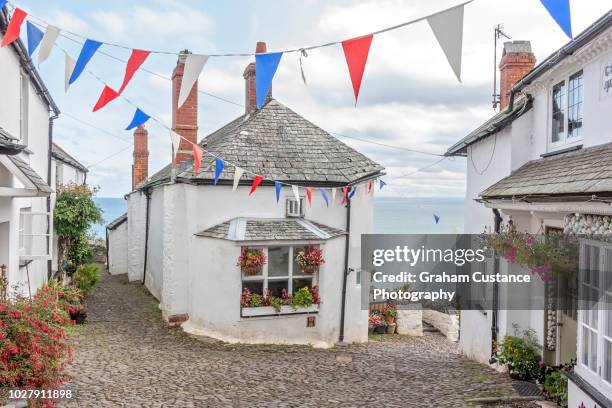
[91,197,464,238]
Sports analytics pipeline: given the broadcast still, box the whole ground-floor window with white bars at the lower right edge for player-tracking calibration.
[576,241,612,398]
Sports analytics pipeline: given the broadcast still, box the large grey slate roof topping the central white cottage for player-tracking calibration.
[141,98,384,188]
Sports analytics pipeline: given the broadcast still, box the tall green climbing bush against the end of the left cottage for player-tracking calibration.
[53,184,102,268]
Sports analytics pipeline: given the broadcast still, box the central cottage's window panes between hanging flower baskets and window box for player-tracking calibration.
[242,246,316,297]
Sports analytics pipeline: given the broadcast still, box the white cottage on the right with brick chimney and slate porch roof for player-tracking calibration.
[447,9,612,408]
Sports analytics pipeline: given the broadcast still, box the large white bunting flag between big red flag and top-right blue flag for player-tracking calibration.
[427,5,463,82]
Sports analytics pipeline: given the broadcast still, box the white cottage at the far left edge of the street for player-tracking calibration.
[0,4,59,294]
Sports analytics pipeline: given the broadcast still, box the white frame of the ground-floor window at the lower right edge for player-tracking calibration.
[575,239,612,399]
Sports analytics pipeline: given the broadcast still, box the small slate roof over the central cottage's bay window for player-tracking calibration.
[195,218,346,241]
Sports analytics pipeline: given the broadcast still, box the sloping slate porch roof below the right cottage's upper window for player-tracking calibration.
[480,143,612,198]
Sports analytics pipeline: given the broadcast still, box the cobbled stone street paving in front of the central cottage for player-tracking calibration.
[60,273,535,407]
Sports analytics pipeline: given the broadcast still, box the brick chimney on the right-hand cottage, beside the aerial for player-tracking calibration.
[499,41,536,110]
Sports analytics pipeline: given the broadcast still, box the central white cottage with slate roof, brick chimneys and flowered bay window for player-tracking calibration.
[109,43,383,347]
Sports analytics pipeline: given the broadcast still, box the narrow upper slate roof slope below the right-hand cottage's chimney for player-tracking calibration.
[446,96,533,156]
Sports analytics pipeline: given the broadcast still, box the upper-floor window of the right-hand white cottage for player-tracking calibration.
[550,71,584,147]
